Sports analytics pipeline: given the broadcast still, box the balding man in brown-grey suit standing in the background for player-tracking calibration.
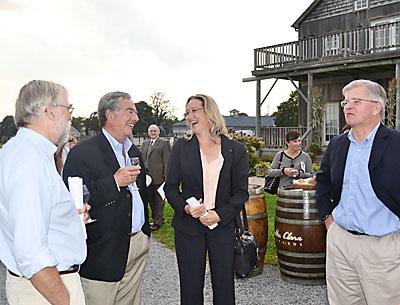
[142,125,171,230]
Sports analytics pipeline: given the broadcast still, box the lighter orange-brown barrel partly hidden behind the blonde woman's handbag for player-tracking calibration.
[241,187,268,276]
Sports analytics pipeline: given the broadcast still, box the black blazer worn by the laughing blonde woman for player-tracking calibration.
[164,136,249,241]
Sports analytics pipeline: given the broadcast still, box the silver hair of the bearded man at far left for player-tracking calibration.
[14,80,68,128]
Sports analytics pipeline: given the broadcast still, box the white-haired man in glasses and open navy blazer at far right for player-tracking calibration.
[317,80,400,305]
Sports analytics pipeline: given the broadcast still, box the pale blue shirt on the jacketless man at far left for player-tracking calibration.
[0,128,86,279]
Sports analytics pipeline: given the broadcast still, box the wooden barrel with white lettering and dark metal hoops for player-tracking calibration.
[275,189,326,285]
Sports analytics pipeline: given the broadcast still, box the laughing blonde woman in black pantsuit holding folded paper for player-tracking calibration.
[164,94,249,305]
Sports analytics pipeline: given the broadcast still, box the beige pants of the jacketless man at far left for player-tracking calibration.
[6,272,85,305]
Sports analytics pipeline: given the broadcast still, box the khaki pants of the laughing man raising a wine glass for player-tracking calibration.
[82,232,149,305]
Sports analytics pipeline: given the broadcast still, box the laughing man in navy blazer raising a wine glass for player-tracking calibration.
[63,92,150,305]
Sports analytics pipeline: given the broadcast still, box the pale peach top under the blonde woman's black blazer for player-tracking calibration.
[200,149,224,210]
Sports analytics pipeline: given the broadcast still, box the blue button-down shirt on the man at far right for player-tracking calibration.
[332,124,400,236]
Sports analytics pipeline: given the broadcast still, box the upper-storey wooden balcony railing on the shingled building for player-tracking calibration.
[254,21,400,70]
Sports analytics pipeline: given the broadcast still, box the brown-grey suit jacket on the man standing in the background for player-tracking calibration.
[142,138,171,184]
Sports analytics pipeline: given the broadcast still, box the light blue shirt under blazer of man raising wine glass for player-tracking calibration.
[102,128,144,232]
